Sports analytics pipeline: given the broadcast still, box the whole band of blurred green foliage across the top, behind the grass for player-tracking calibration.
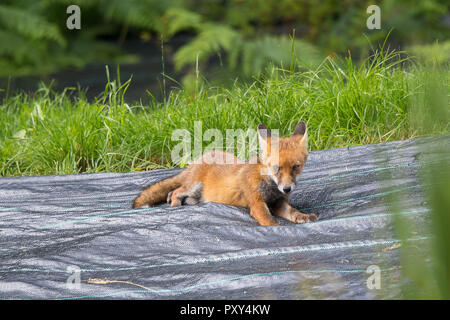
[0,0,448,79]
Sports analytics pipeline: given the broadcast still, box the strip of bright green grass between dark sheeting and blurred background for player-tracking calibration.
[0,52,450,176]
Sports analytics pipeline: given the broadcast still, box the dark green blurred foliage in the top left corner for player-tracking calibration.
[0,0,128,75]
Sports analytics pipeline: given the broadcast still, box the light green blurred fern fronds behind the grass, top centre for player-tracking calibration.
[164,5,322,77]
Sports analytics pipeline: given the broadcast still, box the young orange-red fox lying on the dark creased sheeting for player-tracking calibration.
[133,121,317,226]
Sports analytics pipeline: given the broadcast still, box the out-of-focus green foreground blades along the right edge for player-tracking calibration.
[388,66,450,300]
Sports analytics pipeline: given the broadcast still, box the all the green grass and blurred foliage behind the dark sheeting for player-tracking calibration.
[0,0,450,175]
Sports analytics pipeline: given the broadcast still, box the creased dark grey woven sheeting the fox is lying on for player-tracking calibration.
[0,136,449,299]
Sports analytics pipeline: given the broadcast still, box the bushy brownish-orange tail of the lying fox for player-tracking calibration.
[133,172,184,209]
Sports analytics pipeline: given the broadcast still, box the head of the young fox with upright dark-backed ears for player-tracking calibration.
[258,121,308,195]
